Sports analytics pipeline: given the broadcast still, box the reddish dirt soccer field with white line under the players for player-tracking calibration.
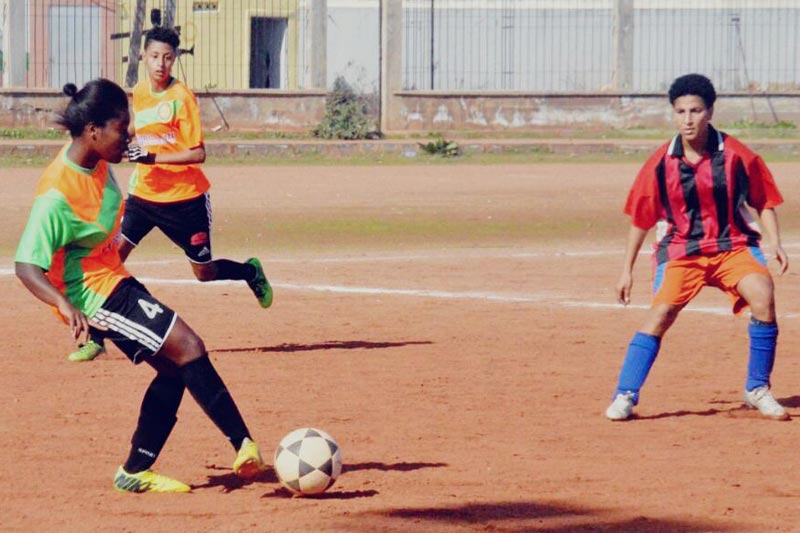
[0,163,800,532]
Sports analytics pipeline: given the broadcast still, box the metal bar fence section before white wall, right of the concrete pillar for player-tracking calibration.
[403,0,800,93]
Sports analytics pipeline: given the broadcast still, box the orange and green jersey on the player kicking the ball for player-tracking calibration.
[15,145,130,317]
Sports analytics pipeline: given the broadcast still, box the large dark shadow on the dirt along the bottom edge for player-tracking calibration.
[367,501,727,532]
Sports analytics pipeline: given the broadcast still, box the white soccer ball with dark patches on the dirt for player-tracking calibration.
[273,428,342,496]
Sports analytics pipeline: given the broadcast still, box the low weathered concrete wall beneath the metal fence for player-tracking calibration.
[0,90,800,133]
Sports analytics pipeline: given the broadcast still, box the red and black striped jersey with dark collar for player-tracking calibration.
[625,125,783,264]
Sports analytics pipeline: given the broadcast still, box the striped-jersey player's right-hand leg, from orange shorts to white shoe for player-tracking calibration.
[717,248,789,420]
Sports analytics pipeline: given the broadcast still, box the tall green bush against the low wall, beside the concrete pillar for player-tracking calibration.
[313,76,374,139]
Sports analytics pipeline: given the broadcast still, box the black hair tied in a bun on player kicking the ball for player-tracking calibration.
[56,78,128,138]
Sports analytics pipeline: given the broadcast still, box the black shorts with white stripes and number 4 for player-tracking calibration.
[91,278,178,365]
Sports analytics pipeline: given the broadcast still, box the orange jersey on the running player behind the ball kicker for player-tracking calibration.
[128,79,210,203]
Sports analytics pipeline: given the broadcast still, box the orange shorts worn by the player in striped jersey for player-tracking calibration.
[653,247,770,314]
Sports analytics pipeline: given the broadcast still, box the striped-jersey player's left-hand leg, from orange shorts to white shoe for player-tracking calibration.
[606,261,704,420]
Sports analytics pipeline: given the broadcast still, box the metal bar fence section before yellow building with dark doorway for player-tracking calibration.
[0,0,312,89]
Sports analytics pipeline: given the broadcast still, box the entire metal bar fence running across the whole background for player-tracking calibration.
[0,0,800,94]
